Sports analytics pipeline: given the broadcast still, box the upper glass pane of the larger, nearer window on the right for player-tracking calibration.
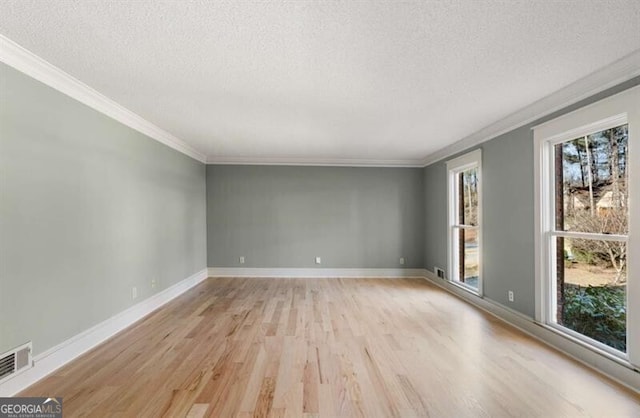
[554,125,628,235]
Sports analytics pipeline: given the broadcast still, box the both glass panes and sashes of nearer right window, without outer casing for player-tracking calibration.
[549,124,629,352]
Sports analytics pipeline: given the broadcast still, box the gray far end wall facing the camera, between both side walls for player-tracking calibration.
[207,165,424,268]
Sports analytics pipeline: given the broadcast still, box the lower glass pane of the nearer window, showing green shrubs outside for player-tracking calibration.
[555,237,627,352]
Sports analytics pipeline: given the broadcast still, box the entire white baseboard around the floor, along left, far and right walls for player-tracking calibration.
[0,267,640,397]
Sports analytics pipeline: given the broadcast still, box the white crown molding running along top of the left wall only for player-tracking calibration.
[0,35,206,163]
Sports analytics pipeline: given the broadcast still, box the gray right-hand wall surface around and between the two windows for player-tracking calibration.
[424,77,640,317]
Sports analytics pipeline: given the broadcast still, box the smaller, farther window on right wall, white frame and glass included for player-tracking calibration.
[447,150,482,294]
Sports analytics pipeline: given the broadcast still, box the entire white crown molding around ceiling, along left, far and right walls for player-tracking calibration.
[0,35,640,167]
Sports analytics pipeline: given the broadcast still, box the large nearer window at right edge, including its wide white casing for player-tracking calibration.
[534,84,640,364]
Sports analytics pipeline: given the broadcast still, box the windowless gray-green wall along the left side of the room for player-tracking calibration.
[0,64,206,354]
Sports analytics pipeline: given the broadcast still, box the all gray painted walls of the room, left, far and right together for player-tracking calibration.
[0,54,640,360]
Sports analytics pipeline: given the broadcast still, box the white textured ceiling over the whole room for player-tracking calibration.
[0,0,640,163]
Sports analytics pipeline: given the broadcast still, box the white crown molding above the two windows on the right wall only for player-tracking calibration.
[422,49,640,167]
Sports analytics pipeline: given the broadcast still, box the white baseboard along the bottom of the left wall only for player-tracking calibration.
[0,269,208,397]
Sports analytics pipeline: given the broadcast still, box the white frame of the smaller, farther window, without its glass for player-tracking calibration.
[447,149,483,297]
